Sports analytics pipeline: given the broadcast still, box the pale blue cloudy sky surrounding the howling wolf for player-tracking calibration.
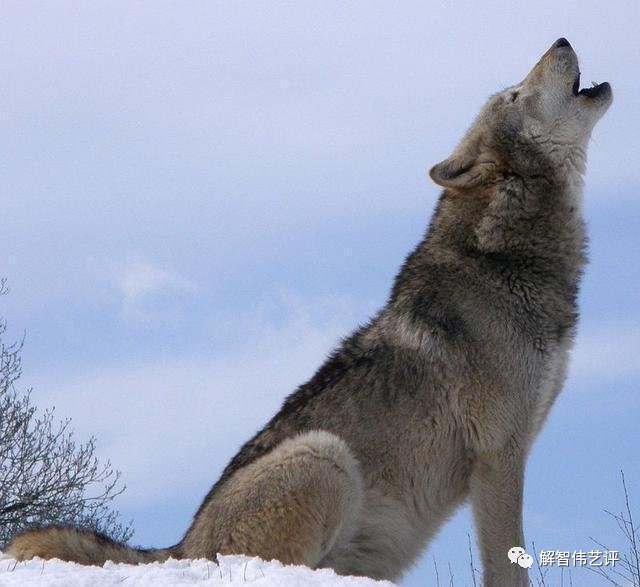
[0,1,640,587]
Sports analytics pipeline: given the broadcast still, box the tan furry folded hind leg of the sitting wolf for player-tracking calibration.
[184,431,362,567]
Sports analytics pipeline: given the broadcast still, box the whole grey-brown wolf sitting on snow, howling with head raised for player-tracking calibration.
[8,38,612,587]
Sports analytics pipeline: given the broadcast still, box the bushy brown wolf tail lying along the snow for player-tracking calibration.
[5,526,179,566]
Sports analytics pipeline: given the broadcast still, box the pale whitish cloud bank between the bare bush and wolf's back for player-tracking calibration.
[32,294,356,506]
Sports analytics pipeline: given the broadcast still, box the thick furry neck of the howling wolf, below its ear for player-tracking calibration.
[425,163,585,270]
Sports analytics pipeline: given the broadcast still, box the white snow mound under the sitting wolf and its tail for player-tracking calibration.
[0,553,393,587]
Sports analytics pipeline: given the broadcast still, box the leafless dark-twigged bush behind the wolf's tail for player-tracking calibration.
[0,279,133,548]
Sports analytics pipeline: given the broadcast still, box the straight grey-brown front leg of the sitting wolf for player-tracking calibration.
[470,446,529,587]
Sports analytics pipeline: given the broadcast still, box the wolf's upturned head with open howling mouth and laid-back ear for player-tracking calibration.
[429,38,612,189]
